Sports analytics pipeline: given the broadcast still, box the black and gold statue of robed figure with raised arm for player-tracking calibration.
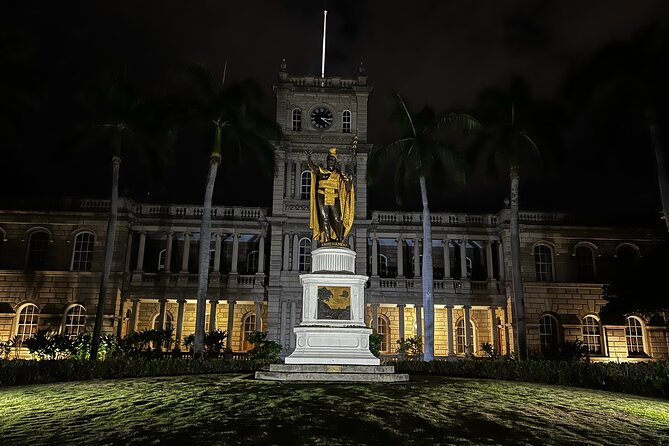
[307,147,355,246]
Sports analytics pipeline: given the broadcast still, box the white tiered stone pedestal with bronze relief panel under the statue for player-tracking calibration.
[285,247,380,365]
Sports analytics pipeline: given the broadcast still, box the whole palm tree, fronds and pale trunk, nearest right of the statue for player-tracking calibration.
[369,93,479,361]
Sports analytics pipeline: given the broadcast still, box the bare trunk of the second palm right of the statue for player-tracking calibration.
[510,166,527,360]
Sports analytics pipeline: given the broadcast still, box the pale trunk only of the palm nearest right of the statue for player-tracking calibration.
[419,176,434,361]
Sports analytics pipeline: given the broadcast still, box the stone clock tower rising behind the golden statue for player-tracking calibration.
[268,60,372,346]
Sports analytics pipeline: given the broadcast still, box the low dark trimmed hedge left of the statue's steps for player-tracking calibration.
[0,358,267,387]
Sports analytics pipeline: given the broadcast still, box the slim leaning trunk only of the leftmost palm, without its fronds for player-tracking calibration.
[91,155,121,361]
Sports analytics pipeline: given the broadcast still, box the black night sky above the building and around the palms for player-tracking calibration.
[0,0,669,222]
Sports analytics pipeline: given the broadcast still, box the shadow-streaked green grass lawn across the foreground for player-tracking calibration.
[0,375,669,446]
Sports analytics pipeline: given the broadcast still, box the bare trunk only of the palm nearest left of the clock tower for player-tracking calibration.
[193,153,221,359]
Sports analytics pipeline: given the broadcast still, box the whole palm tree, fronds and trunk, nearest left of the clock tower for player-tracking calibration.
[179,62,280,358]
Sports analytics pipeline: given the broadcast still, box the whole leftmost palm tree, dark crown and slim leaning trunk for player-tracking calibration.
[91,83,142,360]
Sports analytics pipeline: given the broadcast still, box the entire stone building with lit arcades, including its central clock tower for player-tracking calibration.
[0,68,669,361]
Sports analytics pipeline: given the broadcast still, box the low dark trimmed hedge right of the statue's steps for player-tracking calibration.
[392,359,669,398]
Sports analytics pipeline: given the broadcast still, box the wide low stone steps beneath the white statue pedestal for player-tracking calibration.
[256,364,409,383]
